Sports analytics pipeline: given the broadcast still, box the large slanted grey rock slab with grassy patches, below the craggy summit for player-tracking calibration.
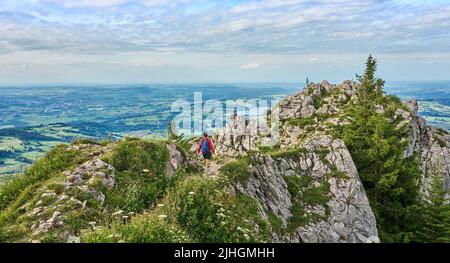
[238,137,379,243]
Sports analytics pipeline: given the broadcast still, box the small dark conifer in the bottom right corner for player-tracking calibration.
[417,175,450,243]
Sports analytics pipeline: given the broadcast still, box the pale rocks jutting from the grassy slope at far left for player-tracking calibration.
[19,159,115,242]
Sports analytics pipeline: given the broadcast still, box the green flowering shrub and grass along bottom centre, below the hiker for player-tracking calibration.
[82,177,270,243]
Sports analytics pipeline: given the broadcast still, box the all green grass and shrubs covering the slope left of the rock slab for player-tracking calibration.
[0,138,273,243]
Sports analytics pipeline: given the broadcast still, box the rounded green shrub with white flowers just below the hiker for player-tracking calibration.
[161,177,269,243]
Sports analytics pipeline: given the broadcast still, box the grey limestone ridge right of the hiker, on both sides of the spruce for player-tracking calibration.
[217,81,450,242]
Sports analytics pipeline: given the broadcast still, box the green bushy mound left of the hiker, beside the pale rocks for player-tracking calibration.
[103,139,182,213]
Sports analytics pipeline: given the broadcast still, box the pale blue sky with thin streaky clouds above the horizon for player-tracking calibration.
[0,0,450,84]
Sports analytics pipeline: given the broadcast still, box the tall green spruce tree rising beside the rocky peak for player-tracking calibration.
[338,56,426,242]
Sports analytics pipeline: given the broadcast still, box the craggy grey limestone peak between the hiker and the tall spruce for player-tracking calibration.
[216,81,379,243]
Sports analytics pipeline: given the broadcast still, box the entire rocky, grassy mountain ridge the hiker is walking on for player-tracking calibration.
[0,77,450,242]
